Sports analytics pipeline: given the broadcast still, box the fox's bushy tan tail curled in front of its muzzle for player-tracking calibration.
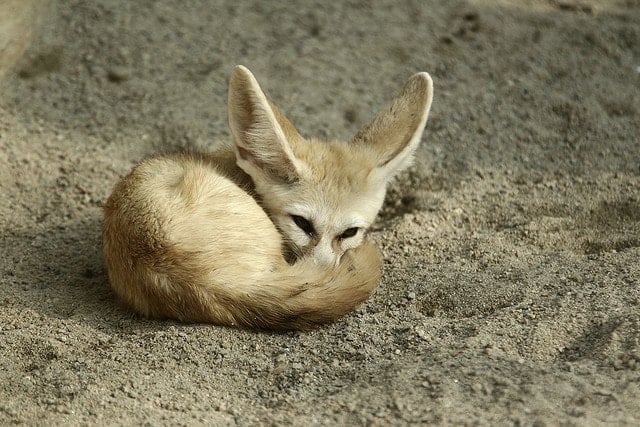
[218,242,382,330]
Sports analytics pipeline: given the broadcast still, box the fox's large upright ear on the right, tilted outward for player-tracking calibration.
[351,73,433,182]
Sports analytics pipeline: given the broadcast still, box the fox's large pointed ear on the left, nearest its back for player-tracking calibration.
[228,65,302,182]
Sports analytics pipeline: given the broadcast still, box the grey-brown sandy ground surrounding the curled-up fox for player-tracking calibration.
[0,0,640,426]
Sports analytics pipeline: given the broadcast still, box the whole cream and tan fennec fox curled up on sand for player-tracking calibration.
[103,66,432,329]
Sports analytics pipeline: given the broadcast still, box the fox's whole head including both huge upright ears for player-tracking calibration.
[228,66,433,266]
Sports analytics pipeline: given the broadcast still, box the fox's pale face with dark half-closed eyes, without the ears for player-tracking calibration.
[256,140,385,265]
